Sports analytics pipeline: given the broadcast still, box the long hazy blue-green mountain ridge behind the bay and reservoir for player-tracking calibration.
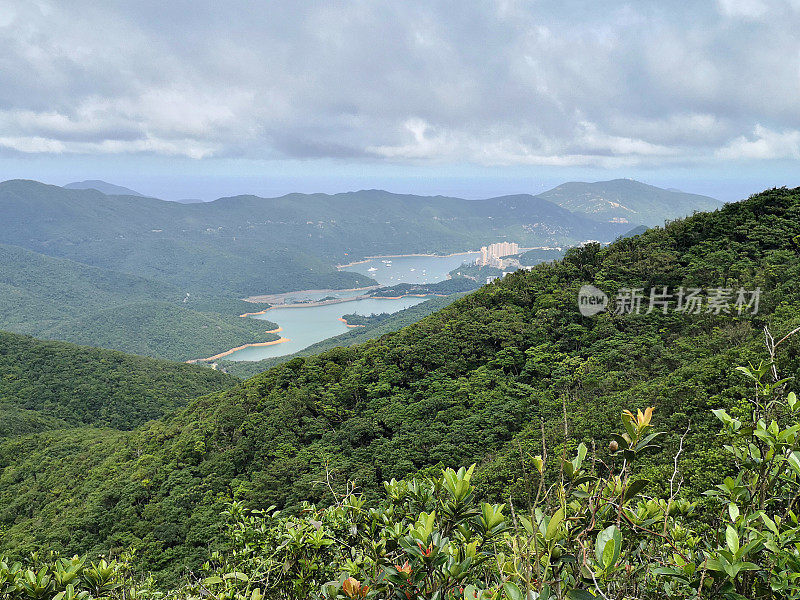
[0,180,630,297]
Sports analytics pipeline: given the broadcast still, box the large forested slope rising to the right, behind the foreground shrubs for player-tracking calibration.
[0,189,800,577]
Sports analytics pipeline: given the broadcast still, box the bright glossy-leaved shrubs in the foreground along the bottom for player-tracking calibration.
[159,370,800,600]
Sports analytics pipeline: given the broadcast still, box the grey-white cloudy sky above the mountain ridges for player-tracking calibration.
[0,0,800,200]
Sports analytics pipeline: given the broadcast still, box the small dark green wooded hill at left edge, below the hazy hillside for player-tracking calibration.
[0,331,239,437]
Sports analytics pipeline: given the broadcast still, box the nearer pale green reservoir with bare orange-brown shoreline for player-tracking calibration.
[225,296,427,360]
